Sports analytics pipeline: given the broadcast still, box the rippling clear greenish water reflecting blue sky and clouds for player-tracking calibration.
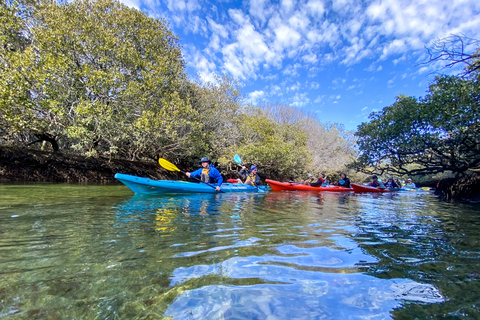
[0,184,480,320]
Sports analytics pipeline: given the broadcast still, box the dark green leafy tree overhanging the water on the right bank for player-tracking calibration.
[356,76,480,174]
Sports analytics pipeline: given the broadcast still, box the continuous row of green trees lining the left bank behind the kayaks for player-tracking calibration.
[0,0,355,178]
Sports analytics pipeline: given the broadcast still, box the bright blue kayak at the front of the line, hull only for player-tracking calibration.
[115,173,263,194]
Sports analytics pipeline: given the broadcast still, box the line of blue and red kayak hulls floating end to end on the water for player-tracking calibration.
[115,173,422,194]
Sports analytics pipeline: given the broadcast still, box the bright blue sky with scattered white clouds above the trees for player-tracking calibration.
[122,0,480,130]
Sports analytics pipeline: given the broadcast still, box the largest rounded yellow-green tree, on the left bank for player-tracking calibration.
[0,0,199,158]
